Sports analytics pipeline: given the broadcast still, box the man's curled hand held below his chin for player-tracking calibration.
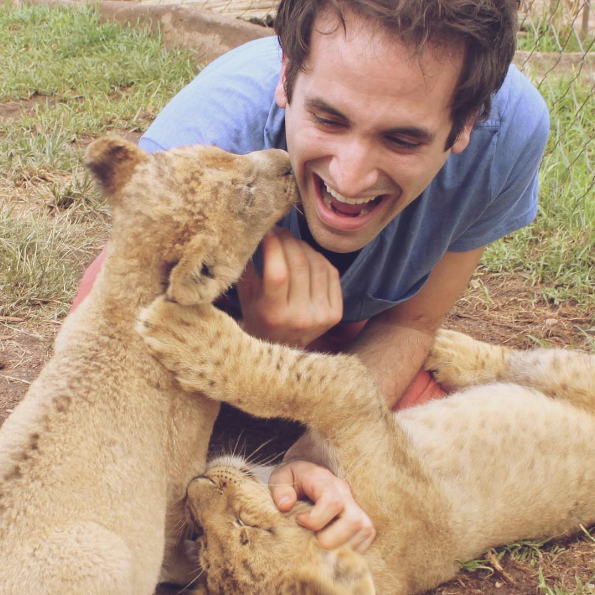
[237,228,343,347]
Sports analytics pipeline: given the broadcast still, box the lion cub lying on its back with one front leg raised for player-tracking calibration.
[139,300,595,595]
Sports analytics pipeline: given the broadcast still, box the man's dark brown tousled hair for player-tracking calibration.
[275,0,520,149]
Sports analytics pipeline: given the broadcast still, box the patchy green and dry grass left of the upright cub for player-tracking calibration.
[0,4,197,319]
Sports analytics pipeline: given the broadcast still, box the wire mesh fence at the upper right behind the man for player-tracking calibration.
[516,0,595,203]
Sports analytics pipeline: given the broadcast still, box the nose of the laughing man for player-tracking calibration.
[329,138,380,197]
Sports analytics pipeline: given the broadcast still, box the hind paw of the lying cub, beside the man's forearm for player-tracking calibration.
[424,330,505,390]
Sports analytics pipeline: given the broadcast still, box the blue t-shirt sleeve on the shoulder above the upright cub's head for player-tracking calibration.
[139,37,283,154]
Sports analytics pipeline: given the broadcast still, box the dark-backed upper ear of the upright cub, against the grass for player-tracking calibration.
[85,136,147,201]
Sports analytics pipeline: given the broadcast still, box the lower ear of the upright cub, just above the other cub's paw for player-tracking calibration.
[167,233,227,306]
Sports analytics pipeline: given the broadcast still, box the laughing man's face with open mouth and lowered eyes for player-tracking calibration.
[276,16,471,252]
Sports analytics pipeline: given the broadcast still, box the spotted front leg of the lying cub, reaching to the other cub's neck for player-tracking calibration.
[137,297,389,436]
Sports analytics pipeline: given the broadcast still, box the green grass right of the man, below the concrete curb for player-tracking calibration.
[483,75,595,307]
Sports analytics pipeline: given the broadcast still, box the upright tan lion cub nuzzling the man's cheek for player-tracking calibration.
[0,137,296,595]
